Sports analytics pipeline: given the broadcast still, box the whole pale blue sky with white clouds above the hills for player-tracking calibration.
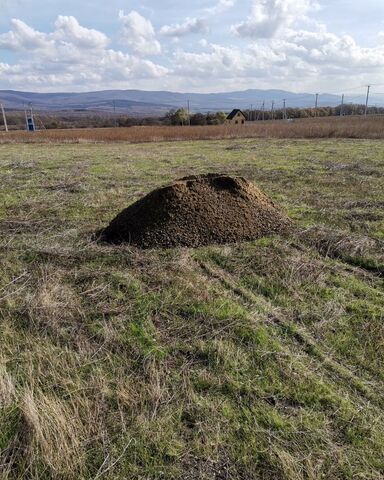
[0,0,384,98]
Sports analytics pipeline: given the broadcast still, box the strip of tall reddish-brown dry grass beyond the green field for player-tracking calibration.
[0,116,384,144]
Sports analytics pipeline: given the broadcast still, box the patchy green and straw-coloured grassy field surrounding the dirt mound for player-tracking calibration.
[0,139,384,480]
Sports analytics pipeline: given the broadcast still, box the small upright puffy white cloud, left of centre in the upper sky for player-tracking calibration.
[119,10,161,55]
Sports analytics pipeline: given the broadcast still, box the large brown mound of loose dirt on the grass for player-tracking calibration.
[102,174,291,248]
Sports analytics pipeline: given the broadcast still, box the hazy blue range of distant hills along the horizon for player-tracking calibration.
[0,90,376,115]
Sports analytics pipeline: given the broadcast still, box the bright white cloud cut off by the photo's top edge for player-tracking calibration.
[231,0,318,38]
